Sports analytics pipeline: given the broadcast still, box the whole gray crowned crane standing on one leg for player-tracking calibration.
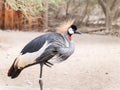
[8,21,81,90]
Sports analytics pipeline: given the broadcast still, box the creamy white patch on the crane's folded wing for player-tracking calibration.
[15,41,50,68]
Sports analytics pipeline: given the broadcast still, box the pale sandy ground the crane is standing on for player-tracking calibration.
[0,31,120,90]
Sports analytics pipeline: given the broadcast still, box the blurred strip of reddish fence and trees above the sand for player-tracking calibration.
[0,0,120,36]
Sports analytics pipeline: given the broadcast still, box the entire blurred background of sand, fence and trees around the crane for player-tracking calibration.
[0,0,120,90]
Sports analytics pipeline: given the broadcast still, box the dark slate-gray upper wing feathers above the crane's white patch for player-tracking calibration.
[21,33,65,54]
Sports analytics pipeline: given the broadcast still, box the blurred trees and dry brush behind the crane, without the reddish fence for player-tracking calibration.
[3,0,120,36]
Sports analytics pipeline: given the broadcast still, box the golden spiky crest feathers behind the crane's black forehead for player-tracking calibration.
[56,19,75,33]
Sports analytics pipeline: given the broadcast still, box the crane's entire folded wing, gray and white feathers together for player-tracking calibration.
[11,33,68,69]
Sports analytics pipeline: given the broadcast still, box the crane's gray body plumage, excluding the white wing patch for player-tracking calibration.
[21,32,74,63]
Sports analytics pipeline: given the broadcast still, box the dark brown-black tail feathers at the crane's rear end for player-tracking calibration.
[8,60,22,78]
